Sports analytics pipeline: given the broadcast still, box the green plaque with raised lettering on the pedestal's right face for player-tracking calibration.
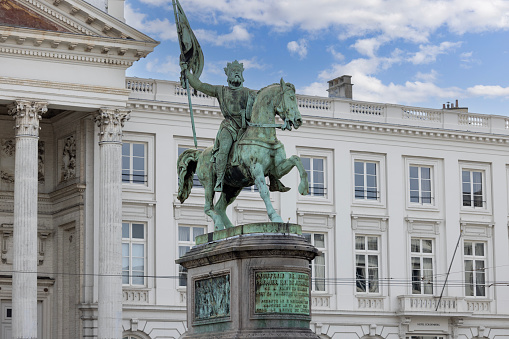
[255,272,309,315]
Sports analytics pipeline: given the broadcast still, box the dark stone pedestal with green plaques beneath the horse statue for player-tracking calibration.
[177,223,319,339]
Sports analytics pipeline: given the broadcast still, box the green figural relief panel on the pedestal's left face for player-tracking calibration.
[194,274,230,320]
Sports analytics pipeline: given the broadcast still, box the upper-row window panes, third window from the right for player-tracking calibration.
[354,161,379,201]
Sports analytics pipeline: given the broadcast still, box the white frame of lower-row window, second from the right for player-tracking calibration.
[408,238,438,296]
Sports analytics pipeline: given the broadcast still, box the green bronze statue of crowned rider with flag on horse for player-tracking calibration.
[173,0,308,230]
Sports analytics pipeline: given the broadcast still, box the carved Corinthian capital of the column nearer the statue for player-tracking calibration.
[95,108,131,143]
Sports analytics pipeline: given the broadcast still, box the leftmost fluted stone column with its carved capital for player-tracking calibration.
[9,100,48,339]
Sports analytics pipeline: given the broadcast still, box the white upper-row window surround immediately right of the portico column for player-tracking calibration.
[122,132,155,193]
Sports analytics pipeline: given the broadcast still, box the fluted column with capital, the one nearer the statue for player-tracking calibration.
[95,108,129,339]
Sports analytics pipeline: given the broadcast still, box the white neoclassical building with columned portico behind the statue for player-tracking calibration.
[0,0,509,339]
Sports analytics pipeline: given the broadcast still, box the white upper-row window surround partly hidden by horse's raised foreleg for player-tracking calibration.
[294,147,334,205]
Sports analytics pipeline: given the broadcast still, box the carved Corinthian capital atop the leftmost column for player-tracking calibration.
[8,99,48,137]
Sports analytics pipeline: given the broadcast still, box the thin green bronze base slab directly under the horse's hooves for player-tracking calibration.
[196,222,302,245]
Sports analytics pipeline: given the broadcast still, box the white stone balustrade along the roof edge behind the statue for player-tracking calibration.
[126,78,509,136]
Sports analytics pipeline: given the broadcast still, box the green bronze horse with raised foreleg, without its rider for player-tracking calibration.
[177,79,308,231]
